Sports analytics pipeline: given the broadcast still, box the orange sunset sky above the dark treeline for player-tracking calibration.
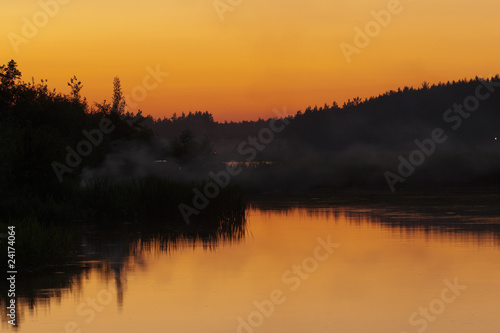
[0,0,500,121]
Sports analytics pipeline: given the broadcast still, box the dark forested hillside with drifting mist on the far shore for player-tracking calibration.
[140,75,500,190]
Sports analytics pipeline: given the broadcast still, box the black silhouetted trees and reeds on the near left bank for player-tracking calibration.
[0,61,245,271]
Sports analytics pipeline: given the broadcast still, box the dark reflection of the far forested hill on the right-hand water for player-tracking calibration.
[252,189,500,246]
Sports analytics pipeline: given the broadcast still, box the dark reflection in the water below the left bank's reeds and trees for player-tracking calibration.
[0,211,246,329]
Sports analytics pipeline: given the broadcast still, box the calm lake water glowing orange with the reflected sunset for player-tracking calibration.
[2,200,500,333]
